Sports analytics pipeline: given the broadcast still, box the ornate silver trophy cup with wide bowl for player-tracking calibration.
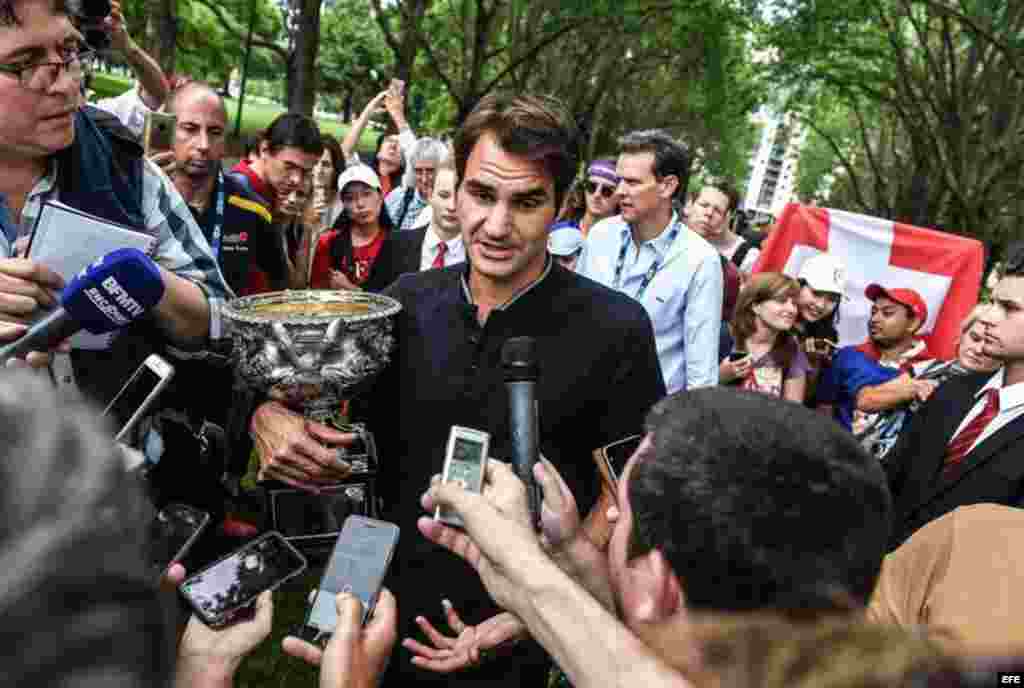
[222,290,401,535]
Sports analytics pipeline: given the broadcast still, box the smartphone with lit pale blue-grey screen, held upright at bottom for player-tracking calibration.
[301,516,399,642]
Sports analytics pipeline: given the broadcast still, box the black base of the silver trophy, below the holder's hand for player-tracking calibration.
[270,483,370,538]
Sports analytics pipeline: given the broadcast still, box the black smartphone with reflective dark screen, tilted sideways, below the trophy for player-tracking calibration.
[178,530,306,628]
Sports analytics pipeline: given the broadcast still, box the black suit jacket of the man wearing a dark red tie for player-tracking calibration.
[886,373,1024,550]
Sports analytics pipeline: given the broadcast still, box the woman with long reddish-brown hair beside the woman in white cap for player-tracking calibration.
[719,272,810,403]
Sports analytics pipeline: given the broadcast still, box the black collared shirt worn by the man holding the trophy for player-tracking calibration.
[368,264,665,685]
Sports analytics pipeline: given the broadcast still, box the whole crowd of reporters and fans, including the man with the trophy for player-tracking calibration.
[0,0,1024,688]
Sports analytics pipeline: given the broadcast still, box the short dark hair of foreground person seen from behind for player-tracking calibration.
[627,387,892,617]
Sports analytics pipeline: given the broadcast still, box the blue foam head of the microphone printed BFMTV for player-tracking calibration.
[60,249,164,334]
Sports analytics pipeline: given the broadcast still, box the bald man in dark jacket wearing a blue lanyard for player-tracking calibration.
[147,83,287,532]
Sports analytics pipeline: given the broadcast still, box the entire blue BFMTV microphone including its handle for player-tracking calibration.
[0,249,164,364]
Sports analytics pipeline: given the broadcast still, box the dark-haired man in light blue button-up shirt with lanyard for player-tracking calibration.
[577,130,722,394]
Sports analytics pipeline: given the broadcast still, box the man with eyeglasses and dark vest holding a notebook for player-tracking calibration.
[0,0,228,400]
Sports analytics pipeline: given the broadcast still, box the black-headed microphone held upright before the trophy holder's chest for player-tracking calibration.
[502,337,541,526]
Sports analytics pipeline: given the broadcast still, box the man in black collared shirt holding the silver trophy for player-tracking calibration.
[253,96,665,686]
